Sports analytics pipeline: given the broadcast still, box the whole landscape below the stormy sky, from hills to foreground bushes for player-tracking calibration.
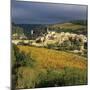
[12,19,87,90]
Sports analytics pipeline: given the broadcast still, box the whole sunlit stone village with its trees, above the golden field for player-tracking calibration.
[12,29,87,55]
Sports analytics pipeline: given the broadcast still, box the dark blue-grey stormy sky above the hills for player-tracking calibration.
[11,0,87,24]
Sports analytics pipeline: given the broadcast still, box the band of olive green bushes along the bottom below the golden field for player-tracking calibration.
[17,67,87,88]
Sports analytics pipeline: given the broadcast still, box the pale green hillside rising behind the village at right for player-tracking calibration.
[48,22,87,35]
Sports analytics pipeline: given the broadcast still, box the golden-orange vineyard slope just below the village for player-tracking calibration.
[19,46,86,69]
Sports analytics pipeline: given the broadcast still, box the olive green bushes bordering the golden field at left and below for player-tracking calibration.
[12,45,87,90]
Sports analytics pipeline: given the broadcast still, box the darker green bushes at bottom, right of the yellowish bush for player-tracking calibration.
[36,68,87,88]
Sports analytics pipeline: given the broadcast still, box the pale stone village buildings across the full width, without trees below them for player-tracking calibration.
[12,29,87,54]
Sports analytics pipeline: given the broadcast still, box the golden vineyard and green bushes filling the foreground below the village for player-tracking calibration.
[12,45,87,88]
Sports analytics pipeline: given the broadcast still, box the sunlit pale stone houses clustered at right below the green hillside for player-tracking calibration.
[36,31,87,53]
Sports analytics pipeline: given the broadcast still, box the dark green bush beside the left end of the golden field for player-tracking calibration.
[14,45,35,67]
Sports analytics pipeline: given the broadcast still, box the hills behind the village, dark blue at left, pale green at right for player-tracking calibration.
[12,21,87,39]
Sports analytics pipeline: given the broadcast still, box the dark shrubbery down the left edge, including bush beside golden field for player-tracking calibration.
[12,45,35,90]
